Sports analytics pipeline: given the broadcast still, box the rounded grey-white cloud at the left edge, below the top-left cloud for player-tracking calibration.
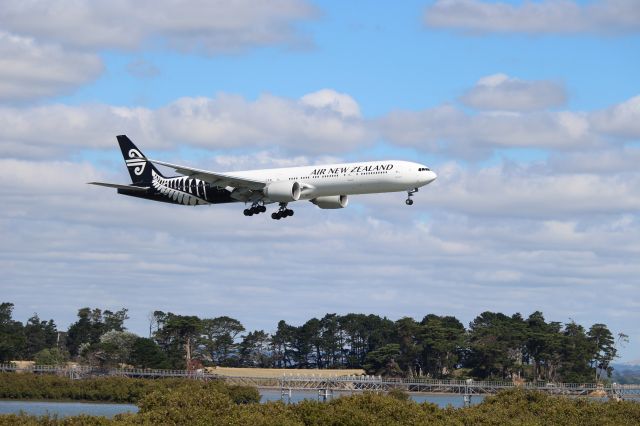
[0,31,103,102]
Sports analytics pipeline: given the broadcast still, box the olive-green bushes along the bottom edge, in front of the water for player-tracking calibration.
[0,382,640,426]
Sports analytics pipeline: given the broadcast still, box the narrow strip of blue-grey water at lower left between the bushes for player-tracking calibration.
[0,401,138,418]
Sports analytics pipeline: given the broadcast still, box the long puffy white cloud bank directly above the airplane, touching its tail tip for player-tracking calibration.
[0,90,372,158]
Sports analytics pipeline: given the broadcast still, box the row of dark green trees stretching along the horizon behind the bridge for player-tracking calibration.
[0,303,627,382]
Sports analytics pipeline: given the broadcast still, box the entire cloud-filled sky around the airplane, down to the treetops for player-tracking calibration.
[0,0,640,361]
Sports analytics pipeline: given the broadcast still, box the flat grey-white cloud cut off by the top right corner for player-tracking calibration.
[425,0,640,34]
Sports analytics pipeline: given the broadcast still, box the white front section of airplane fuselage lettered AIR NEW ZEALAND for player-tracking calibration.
[227,160,437,200]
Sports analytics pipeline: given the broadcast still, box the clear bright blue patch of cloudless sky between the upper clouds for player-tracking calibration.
[58,1,640,117]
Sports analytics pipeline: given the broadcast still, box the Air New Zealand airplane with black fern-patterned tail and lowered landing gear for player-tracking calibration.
[89,135,438,220]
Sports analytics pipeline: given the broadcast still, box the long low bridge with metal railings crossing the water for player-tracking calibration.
[0,364,640,404]
